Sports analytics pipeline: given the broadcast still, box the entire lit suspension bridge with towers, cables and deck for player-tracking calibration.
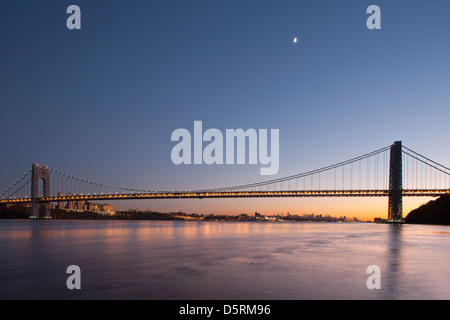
[0,141,450,222]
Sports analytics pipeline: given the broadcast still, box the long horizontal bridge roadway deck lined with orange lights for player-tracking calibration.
[0,189,450,204]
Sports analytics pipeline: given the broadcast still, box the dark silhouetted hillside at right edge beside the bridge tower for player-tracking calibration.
[405,195,450,225]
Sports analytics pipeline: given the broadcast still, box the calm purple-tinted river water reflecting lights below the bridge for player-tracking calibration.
[0,220,450,300]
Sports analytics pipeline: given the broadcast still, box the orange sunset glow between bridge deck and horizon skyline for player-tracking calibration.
[112,197,435,221]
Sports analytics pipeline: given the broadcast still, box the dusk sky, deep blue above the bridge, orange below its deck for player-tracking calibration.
[0,0,450,218]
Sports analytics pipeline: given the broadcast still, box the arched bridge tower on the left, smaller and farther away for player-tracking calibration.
[30,163,50,218]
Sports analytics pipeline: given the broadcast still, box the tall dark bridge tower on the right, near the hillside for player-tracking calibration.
[388,141,403,222]
